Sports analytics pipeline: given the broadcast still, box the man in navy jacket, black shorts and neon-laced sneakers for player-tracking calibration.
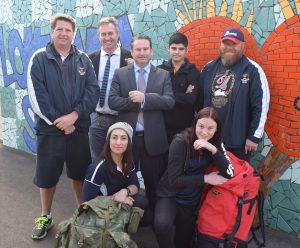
[27,14,99,239]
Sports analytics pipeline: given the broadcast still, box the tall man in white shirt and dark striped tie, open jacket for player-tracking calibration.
[89,17,132,160]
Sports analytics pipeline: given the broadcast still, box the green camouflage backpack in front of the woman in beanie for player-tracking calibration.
[54,196,144,248]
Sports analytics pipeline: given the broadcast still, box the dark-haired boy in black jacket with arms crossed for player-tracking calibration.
[158,33,200,144]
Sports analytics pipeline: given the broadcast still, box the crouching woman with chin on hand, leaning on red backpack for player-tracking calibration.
[154,107,234,248]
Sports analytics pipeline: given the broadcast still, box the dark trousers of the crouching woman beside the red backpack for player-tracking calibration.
[154,197,196,248]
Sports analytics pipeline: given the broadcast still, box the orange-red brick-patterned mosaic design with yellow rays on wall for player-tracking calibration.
[176,0,300,196]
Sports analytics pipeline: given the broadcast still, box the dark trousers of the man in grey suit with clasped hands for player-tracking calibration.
[133,136,164,211]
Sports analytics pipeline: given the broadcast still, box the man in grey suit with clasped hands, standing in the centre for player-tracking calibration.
[108,35,175,209]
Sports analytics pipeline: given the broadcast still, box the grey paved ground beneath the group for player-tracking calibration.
[0,143,300,248]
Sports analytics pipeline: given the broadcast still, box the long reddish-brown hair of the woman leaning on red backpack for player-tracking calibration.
[182,107,222,155]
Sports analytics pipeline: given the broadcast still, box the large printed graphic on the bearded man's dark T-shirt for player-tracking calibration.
[212,70,236,108]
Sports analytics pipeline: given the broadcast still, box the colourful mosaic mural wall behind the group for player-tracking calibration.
[0,0,300,237]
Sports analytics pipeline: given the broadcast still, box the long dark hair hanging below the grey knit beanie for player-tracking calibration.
[98,132,134,177]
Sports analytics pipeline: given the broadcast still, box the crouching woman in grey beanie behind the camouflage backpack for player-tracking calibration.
[83,122,147,209]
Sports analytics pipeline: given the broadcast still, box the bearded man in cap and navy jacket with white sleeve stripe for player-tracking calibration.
[198,27,270,161]
